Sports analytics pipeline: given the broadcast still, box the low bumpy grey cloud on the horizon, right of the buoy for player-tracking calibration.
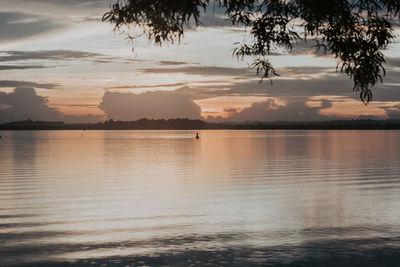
[216,99,332,122]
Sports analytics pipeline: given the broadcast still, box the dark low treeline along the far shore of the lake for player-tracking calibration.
[0,118,400,130]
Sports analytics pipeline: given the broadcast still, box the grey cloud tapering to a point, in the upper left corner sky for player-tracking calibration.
[0,12,66,43]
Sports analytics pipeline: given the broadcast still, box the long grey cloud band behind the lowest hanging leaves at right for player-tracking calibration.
[148,58,400,101]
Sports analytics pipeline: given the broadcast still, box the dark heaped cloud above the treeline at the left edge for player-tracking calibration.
[0,87,62,122]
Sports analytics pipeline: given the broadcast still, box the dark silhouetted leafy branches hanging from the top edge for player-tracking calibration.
[103,0,400,104]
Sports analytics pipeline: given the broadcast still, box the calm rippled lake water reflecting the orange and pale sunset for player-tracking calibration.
[0,131,400,266]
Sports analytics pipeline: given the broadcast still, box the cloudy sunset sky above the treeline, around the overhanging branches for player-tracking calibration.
[0,0,400,123]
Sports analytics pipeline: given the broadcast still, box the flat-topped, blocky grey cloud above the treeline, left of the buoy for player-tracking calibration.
[99,91,201,120]
